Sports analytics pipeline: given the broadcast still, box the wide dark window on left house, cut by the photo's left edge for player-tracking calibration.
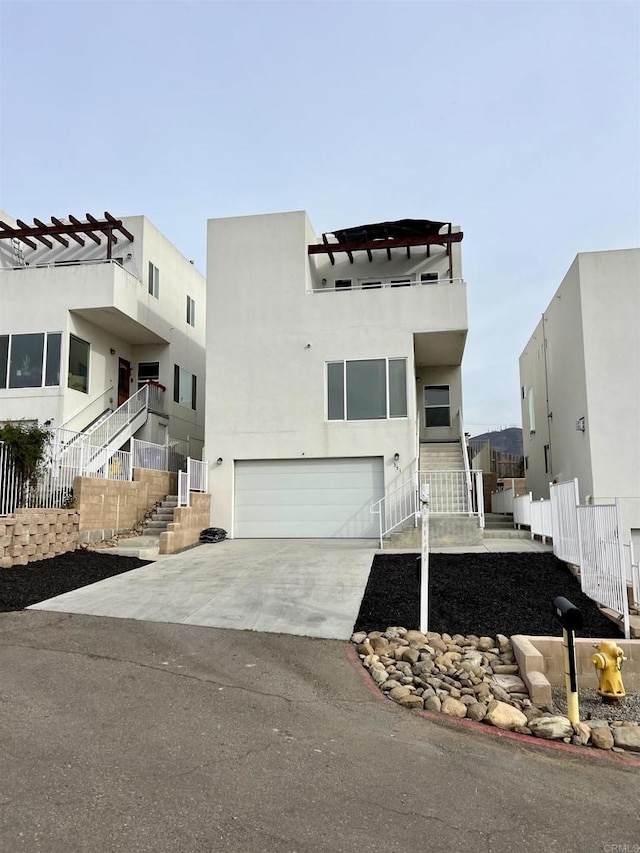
[0,332,61,388]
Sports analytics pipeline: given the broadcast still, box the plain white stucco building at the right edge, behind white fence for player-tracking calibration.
[520,249,640,554]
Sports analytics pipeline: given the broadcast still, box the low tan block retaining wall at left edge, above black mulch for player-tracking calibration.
[0,509,79,569]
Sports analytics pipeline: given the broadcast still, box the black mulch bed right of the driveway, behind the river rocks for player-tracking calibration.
[354,553,623,639]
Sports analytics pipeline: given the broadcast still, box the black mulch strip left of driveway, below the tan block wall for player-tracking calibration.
[0,550,150,612]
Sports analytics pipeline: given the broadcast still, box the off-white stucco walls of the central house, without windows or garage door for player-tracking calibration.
[205,211,467,535]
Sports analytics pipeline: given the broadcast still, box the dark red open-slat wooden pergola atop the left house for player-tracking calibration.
[0,210,134,260]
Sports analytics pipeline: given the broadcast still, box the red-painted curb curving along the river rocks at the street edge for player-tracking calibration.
[347,643,640,768]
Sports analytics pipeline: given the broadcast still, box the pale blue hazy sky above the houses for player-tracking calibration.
[0,0,640,434]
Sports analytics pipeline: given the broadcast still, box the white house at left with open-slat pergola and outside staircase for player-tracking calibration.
[0,213,206,457]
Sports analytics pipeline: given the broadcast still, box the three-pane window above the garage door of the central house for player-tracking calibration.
[327,358,407,421]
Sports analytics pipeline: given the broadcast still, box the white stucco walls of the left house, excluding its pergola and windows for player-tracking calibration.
[0,213,206,455]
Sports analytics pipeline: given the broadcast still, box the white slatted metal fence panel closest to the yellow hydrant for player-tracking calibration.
[576,501,629,639]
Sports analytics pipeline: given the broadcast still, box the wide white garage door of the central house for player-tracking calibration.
[234,457,384,539]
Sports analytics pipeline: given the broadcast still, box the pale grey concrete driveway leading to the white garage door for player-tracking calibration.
[31,539,377,640]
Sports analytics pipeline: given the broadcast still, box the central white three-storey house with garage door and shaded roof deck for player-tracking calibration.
[205,211,467,538]
